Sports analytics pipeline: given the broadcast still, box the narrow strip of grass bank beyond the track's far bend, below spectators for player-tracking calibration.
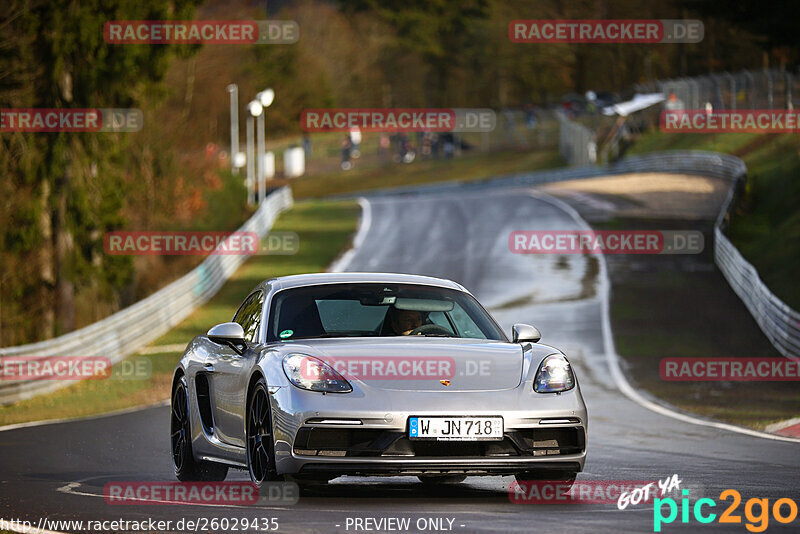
[292,147,564,198]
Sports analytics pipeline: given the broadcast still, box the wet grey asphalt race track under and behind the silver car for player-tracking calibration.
[0,188,800,532]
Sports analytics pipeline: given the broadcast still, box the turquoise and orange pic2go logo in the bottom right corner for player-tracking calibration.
[653,489,797,532]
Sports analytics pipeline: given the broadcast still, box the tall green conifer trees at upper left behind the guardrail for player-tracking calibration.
[0,0,200,337]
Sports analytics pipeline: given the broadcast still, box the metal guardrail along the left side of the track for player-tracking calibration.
[0,187,293,404]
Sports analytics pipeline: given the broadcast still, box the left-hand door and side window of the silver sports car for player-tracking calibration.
[205,290,264,447]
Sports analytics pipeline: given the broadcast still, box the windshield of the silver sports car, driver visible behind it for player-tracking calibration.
[267,283,506,341]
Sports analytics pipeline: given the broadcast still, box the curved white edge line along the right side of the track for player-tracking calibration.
[529,191,800,443]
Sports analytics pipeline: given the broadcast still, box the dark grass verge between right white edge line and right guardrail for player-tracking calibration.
[611,272,800,429]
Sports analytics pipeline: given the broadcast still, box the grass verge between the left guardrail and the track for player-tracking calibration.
[0,202,360,425]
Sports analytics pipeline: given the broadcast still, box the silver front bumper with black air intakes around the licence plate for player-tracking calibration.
[271,387,587,478]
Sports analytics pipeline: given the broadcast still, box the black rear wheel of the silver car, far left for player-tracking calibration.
[170,376,228,482]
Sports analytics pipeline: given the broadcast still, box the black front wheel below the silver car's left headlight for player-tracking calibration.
[245,378,279,487]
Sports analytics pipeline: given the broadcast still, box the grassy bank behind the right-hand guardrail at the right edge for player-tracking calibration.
[629,131,800,309]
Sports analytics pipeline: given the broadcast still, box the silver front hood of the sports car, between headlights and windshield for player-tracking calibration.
[284,336,523,392]
